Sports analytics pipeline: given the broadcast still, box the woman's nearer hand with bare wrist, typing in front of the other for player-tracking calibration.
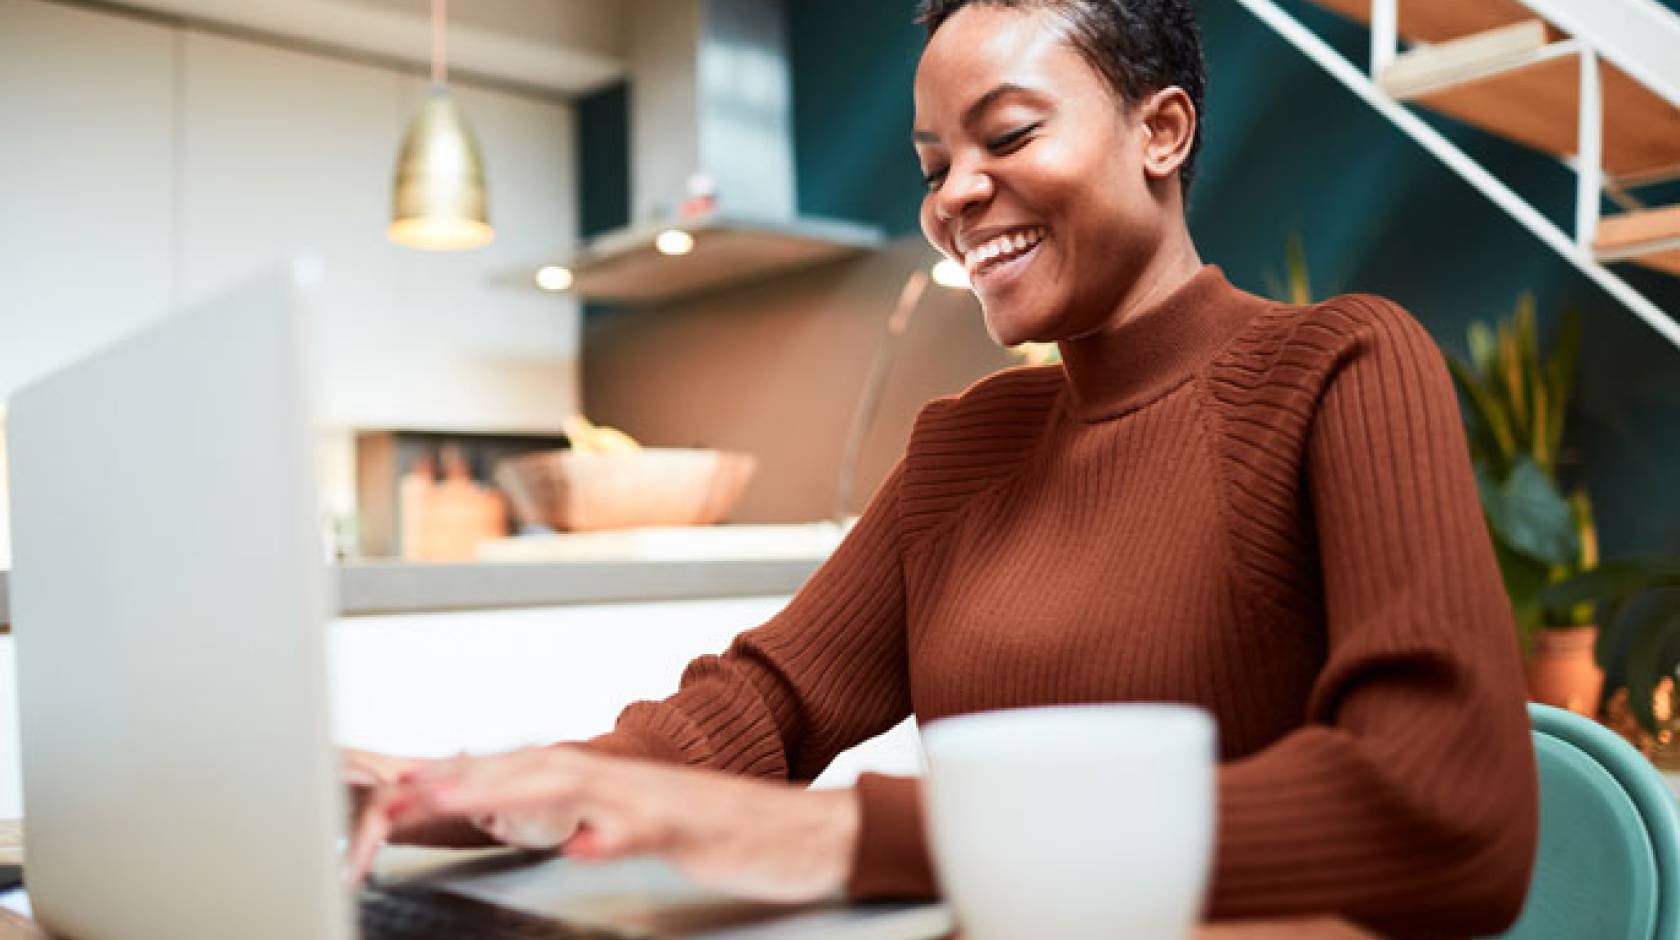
[349,747,858,901]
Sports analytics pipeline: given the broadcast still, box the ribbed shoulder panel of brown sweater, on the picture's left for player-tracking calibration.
[899,366,1067,549]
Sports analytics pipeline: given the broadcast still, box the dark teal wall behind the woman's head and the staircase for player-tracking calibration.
[788,0,1680,554]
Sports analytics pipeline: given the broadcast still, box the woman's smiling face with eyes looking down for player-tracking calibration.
[914,5,1178,346]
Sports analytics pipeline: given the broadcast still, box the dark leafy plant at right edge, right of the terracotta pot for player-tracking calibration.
[1541,556,1680,758]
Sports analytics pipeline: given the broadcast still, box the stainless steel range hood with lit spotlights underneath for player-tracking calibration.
[558,0,882,304]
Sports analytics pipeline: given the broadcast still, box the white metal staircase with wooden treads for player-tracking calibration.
[1236,0,1680,346]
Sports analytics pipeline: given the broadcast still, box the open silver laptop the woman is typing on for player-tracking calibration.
[7,265,951,940]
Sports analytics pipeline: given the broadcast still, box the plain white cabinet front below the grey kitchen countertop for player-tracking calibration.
[329,598,921,786]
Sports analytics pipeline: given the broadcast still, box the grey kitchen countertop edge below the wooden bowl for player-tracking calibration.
[0,556,822,631]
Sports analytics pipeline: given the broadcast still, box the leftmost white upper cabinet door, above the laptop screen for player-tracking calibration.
[0,0,176,400]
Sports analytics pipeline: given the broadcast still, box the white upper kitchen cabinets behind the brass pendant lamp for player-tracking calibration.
[0,0,578,433]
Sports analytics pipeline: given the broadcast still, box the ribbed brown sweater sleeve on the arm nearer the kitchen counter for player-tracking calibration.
[588,463,911,781]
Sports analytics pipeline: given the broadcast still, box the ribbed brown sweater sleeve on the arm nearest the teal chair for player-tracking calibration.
[1211,295,1537,937]
